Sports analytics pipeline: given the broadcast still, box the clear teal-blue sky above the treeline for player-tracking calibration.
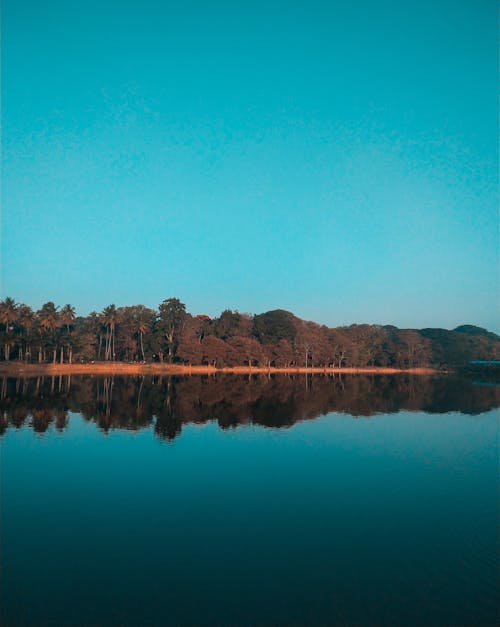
[0,0,500,331]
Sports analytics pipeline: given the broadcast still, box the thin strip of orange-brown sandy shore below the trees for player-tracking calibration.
[0,362,438,377]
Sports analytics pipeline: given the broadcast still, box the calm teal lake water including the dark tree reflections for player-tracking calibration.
[0,376,500,627]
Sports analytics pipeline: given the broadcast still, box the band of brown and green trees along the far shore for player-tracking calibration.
[0,297,500,369]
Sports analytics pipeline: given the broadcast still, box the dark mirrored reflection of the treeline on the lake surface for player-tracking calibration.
[0,374,500,440]
